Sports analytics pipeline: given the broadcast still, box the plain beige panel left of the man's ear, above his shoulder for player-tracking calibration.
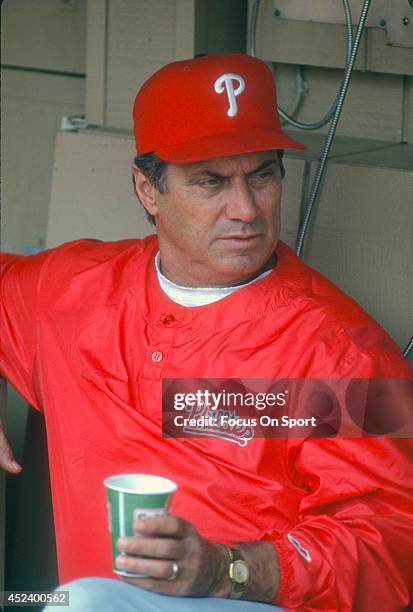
[46,131,154,247]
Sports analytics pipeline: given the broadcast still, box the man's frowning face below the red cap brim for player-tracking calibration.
[135,151,281,287]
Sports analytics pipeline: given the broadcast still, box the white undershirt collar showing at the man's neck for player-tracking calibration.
[155,251,272,307]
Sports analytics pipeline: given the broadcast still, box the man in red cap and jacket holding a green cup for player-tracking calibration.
[2,55,413,612]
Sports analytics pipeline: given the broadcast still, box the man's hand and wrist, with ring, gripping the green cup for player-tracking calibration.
[116,515,279,602]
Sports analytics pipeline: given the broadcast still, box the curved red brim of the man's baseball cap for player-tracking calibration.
[155,129,307,164]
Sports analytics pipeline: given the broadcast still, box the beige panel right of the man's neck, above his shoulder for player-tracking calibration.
[304,159,413,347]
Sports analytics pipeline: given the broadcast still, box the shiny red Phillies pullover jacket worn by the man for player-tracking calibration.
[1,236,413,612]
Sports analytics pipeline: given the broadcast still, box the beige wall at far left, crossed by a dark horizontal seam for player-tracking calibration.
[1,0,86,252]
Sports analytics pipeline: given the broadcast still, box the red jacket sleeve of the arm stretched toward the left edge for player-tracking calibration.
[0,251,49,410]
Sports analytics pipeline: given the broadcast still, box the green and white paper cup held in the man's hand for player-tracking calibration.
[103,474,177,578]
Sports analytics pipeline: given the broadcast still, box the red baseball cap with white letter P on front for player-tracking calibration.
[133,54,306,163]
